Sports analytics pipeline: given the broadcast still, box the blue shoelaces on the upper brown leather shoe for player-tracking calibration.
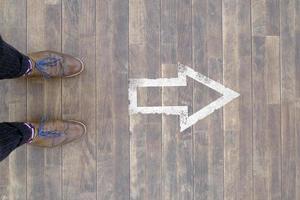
[35,56,62,79]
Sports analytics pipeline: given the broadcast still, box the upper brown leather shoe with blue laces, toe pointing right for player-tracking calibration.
[27,51,84,78]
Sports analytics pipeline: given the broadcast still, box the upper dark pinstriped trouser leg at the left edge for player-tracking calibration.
[0,36,32,80]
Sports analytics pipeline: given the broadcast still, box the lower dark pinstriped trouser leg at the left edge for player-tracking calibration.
[0,122,34,162]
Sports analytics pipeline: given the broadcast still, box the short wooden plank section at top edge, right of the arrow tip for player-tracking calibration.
[251,0,280,36]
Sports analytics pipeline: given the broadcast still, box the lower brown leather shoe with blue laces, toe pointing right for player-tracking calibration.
[30,120,86,147]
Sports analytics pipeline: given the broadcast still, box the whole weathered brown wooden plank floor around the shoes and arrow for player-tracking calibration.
[0,0,300,200]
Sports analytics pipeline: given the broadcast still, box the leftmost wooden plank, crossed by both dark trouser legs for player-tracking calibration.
[0,0,26,200]
